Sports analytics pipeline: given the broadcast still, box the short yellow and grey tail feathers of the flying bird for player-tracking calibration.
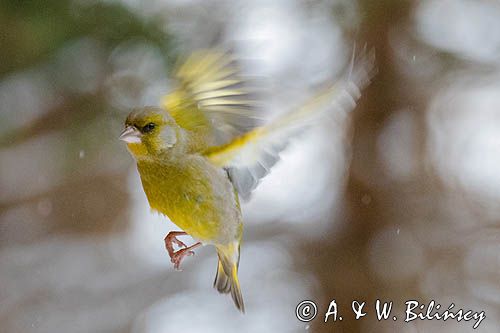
[214,242,245,313]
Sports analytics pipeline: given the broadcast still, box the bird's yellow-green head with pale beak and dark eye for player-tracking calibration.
[120,107,181,159]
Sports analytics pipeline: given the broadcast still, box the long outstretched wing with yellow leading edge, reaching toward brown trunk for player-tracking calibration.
[206,50,376,197]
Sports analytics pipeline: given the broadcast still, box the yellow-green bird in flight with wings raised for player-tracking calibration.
[119,47,375,313]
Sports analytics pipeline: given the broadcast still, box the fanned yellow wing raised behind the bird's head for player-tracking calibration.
[162,49,260,146]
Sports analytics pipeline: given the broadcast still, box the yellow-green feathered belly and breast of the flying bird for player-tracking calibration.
[141,157,241,244]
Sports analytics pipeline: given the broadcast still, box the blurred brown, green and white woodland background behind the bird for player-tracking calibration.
[0,0,500,333]
